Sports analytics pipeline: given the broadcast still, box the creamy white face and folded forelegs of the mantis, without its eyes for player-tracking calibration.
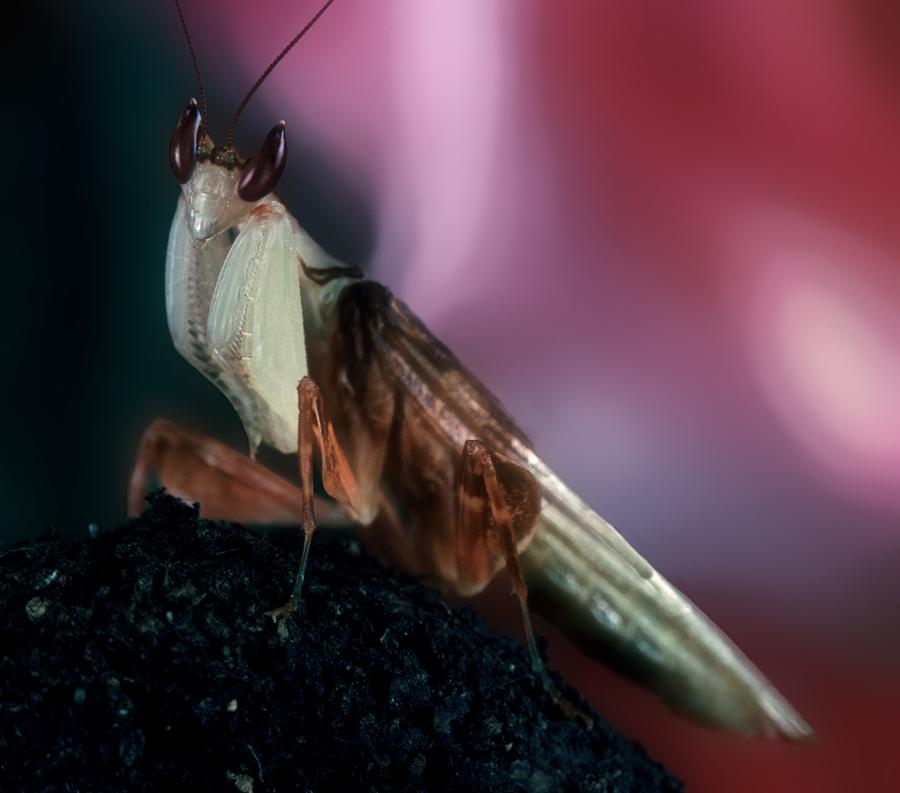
[166,156,333,455]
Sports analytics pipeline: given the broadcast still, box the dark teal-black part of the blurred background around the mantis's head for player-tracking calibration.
[0,0,372,539]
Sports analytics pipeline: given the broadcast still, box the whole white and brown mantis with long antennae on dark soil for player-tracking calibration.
[129,0,812,740]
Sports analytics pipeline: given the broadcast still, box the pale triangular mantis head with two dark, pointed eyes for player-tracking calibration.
[169,99,287,240]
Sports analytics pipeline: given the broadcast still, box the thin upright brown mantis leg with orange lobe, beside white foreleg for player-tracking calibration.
[269,377,367,620]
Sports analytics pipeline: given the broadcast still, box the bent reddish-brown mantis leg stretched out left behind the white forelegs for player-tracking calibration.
[128,419,352,526]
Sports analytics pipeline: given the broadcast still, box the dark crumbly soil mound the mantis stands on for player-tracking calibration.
[0,494,681,793]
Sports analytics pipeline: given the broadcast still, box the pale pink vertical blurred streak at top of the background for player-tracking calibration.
[379,2,507,317]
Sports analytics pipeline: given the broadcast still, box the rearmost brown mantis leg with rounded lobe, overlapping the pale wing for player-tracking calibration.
[457,440,593,728]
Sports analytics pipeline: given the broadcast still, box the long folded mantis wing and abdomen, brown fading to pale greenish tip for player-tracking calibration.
[376,290,812,740]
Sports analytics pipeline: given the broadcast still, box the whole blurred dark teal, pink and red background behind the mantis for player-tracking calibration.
[0,0,900,792]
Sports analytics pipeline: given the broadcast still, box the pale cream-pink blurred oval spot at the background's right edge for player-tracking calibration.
[738,210,900,505]
